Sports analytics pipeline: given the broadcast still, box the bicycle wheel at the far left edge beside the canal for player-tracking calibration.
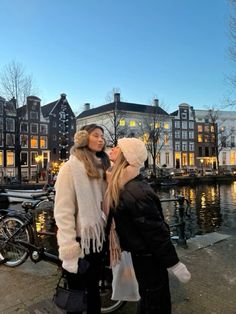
[0,216,32,267]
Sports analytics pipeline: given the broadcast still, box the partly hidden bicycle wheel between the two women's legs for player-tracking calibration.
[99,267,126,314]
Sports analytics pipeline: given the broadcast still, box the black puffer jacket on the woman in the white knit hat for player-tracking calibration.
[112,175,179,268]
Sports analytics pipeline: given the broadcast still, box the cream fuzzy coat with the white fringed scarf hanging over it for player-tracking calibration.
[54,155,105,261]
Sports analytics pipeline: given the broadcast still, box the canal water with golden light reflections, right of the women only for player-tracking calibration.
[157,182,236,237]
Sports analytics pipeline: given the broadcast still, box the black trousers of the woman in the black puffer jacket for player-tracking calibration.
[132,254,171,314]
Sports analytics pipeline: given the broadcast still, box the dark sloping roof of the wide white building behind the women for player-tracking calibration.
[77,102,169,118]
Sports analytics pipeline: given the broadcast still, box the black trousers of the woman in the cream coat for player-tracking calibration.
[64,253,102,314]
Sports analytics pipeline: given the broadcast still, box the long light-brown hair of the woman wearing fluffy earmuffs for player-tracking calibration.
[70,145,102,179]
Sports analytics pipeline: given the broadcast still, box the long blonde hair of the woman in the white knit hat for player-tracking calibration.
[105,151,129,208]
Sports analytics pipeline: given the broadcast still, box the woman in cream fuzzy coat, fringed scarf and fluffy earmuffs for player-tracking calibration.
[54,124,109,314]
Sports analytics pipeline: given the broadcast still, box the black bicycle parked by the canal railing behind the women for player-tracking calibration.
[0,192,126,313]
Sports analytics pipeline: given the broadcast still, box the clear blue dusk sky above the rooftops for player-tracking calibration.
[0,0,233,113]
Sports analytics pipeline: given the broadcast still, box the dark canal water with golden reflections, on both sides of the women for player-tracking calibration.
[7,181,236,247]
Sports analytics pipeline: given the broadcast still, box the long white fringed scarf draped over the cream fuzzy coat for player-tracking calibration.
[68,155,105,254]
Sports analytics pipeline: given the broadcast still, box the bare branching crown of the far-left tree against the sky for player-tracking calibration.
[0,61,34,108]
